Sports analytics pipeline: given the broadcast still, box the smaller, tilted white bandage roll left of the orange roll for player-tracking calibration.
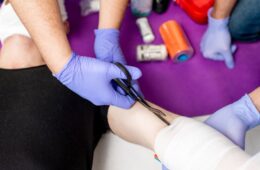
[136,17,155,43]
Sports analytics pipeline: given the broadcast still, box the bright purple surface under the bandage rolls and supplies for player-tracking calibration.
[67,0,260,116]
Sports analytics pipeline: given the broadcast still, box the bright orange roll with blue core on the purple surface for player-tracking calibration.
[159,20,194,62]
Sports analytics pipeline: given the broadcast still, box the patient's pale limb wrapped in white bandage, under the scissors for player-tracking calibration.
[108,99,260,170]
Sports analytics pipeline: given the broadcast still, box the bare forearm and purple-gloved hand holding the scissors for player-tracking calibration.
[10,0,141,108]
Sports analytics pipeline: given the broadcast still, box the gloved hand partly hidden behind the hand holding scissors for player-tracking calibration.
[94,29,126,64]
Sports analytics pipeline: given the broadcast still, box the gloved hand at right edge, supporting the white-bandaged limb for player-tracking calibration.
[205,95,260,149]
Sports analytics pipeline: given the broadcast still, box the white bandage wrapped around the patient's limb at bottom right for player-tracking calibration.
[155,117,259,170]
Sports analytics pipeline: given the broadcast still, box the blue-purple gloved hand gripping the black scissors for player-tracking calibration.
[54,53,141,108]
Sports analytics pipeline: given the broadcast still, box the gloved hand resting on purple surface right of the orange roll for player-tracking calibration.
[200,8,236,69]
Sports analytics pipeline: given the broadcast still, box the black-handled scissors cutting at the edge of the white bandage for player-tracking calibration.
[113,62,170,125]
